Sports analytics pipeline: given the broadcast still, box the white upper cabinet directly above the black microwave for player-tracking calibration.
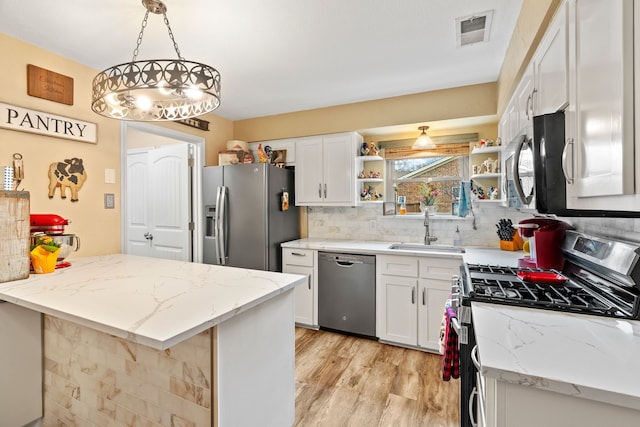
[532,3,569,115]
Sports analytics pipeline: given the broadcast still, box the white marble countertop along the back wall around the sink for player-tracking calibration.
[282,238,524,265]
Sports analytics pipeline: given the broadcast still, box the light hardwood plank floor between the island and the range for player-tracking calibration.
[295,328,460,427]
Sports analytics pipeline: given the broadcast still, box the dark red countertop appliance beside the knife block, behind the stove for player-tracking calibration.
[514,218,573,271]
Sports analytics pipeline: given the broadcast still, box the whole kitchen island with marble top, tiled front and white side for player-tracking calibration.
[0,254,305,426]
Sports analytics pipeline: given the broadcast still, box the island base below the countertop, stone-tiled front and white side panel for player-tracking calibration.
[43,290,295,427]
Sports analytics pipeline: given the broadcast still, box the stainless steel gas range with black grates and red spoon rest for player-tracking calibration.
[452,231,640,427]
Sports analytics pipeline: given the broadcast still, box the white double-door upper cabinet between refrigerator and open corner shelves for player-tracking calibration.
[295,132,362,206]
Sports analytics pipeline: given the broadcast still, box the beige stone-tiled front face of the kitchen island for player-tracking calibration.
[43,316,212,426]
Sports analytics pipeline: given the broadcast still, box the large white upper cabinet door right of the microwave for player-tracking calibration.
[564,0,638,210]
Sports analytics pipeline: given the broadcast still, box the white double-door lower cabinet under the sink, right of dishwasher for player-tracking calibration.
[376,255,462,352]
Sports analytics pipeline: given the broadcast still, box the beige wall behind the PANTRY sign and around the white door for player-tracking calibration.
[0,34,233,261]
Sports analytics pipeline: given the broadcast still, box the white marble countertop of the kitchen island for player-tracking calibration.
[0,254,304,350]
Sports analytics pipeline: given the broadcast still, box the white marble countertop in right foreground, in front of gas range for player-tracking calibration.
[472,302,640,412]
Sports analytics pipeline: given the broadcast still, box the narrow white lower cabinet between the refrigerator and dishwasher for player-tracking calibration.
[282,248,318,328]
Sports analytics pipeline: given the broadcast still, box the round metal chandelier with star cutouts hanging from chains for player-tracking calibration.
[91,0,220,121]
